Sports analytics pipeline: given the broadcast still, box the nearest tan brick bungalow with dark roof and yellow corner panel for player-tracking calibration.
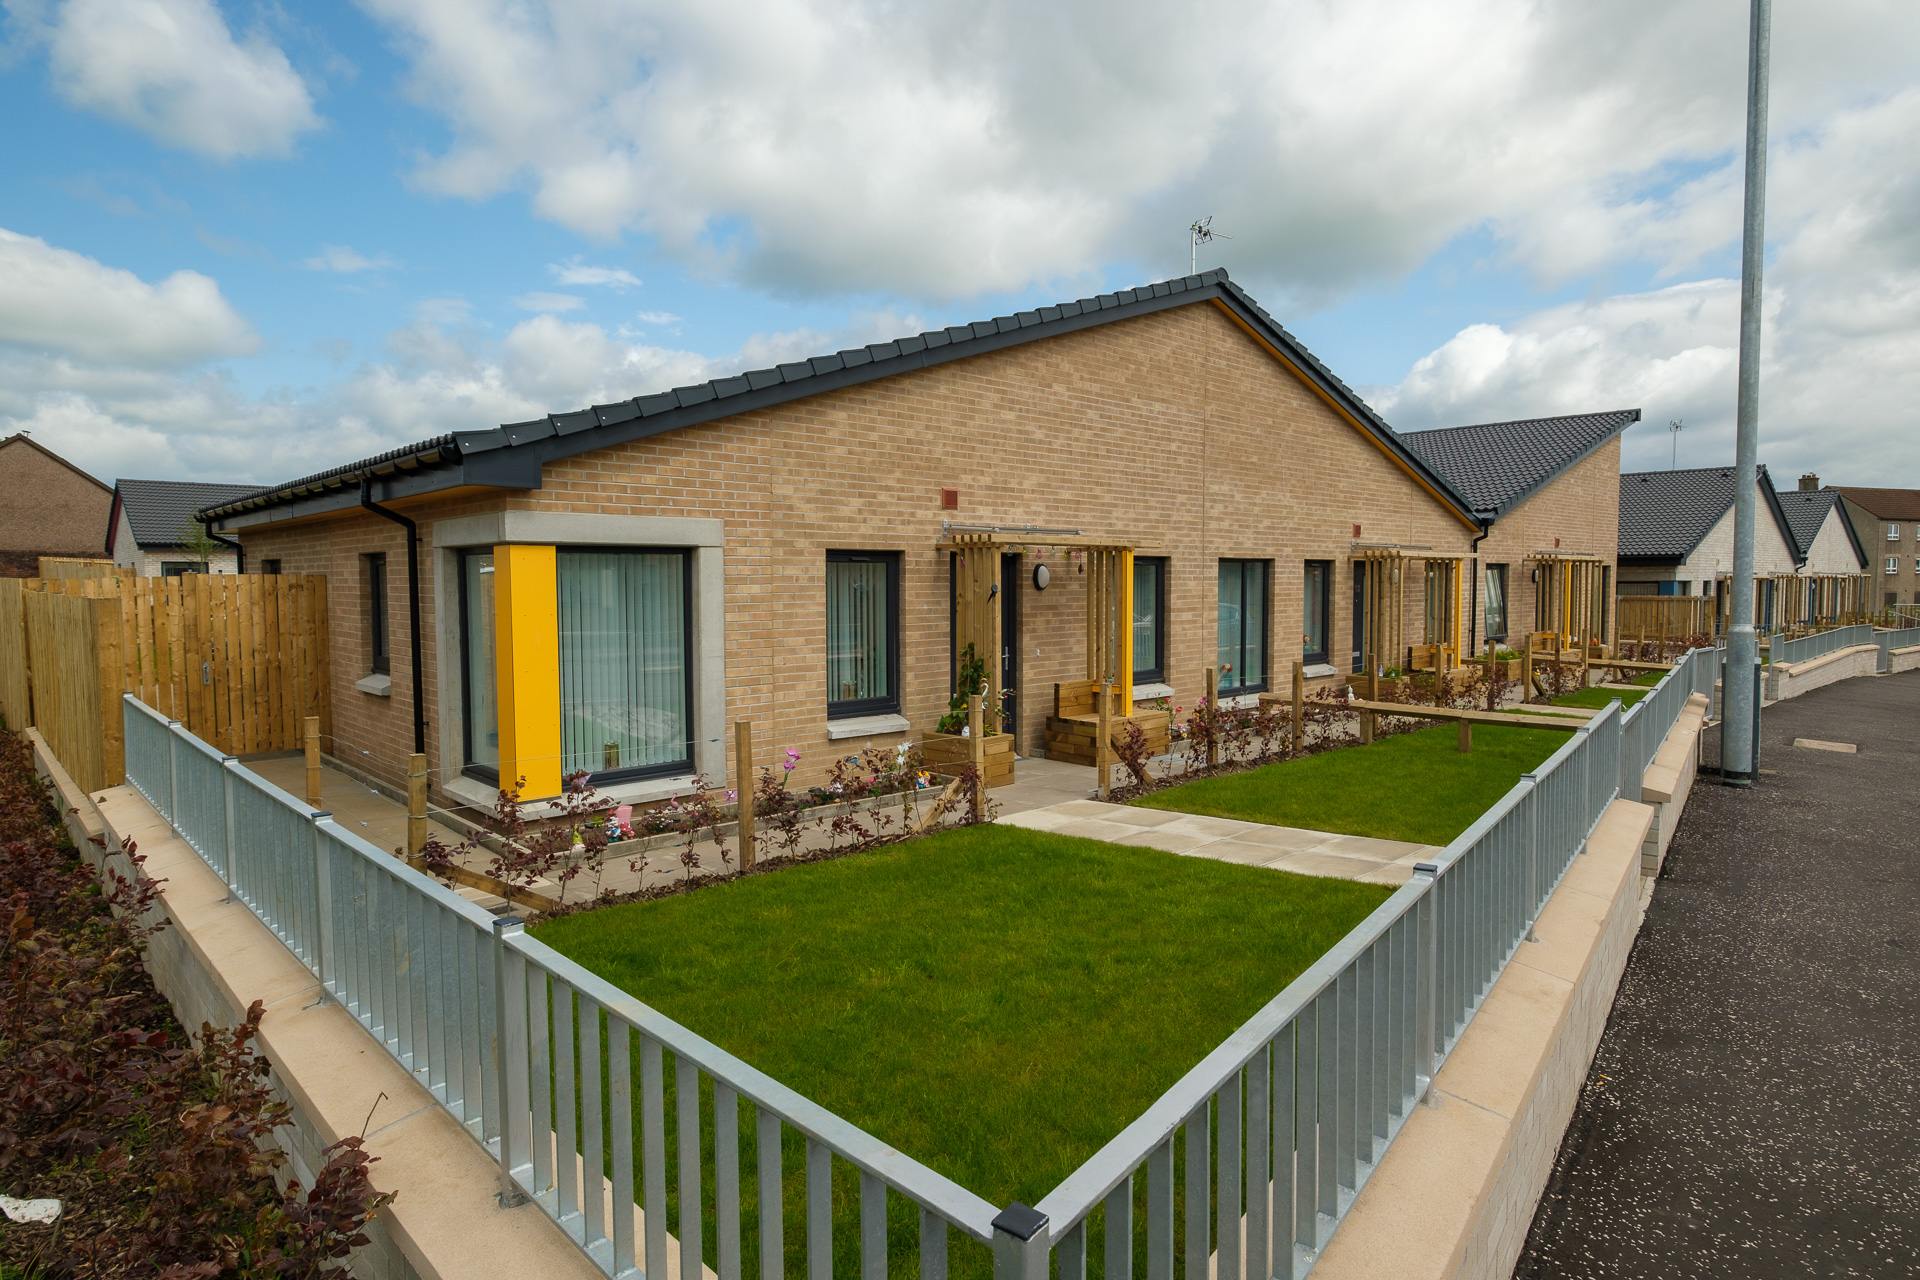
[204,271,1617,804]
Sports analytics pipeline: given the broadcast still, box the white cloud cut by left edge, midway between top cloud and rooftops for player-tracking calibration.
[0,228,259,368]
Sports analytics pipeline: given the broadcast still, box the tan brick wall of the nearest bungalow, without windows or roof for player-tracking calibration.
[232,303,1619,802]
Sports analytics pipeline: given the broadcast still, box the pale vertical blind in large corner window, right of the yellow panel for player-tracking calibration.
[559,551,693,775]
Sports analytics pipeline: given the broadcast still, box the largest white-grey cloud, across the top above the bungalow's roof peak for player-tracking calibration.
[361,0,1920,305]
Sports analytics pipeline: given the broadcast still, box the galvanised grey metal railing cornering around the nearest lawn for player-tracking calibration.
[125,687,1681,1280]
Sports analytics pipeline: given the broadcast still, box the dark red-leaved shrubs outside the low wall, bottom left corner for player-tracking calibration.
[0,729,390,1280]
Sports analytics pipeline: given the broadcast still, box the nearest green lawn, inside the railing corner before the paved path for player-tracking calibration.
[534,825,1392,1274]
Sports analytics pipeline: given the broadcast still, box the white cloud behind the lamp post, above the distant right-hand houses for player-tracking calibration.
[1371,88,1920,484]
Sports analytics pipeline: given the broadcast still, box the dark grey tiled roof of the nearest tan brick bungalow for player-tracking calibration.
[204,271,1478,530]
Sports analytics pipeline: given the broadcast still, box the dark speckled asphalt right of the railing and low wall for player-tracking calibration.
[1515,672,1920,1280]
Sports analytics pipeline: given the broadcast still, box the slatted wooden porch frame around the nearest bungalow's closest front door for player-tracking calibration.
[935,524,1137,716]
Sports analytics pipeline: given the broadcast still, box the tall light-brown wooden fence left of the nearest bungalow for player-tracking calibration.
[0,574,332,787]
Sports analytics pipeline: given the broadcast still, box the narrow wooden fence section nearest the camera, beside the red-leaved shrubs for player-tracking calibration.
[25,591,127,791]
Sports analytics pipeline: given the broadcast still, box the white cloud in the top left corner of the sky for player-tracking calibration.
[26,0,321,159]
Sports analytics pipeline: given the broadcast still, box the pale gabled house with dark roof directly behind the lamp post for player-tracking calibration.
[1620,466,1805,626]
